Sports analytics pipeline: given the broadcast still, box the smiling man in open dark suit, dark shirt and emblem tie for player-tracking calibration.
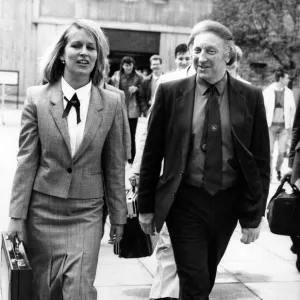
[138,20,270,300]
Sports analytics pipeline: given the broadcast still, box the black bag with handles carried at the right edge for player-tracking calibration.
[267,178,300,236]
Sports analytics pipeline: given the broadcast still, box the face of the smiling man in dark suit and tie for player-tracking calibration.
[192,32,229,84]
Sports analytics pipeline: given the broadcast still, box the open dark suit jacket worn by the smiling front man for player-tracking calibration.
[138,74,270,232]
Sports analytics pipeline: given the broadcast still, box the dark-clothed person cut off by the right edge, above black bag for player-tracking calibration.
[282,105,300,272]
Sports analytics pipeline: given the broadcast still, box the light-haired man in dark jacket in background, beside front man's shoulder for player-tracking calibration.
[140,55,162,109]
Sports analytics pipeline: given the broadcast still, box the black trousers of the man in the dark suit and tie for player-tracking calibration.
[167,183,239,300]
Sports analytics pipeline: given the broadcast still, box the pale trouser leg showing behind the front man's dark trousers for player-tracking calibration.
[149,224,179,299]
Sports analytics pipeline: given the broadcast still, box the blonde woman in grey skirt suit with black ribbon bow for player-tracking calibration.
[8,20,127,300]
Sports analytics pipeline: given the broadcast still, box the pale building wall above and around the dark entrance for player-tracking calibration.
[0,0,212,95]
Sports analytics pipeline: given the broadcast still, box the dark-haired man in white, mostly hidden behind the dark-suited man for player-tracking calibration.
[130,44,195,300]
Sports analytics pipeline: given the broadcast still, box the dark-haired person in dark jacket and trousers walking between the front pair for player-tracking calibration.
[111,56,148,164]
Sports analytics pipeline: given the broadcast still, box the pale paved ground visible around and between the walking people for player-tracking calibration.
[0,104,300,300]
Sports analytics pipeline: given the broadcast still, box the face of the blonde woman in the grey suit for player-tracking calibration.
[60,28,98,84]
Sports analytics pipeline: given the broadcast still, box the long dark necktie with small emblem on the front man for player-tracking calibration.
[201,85,222,195]
